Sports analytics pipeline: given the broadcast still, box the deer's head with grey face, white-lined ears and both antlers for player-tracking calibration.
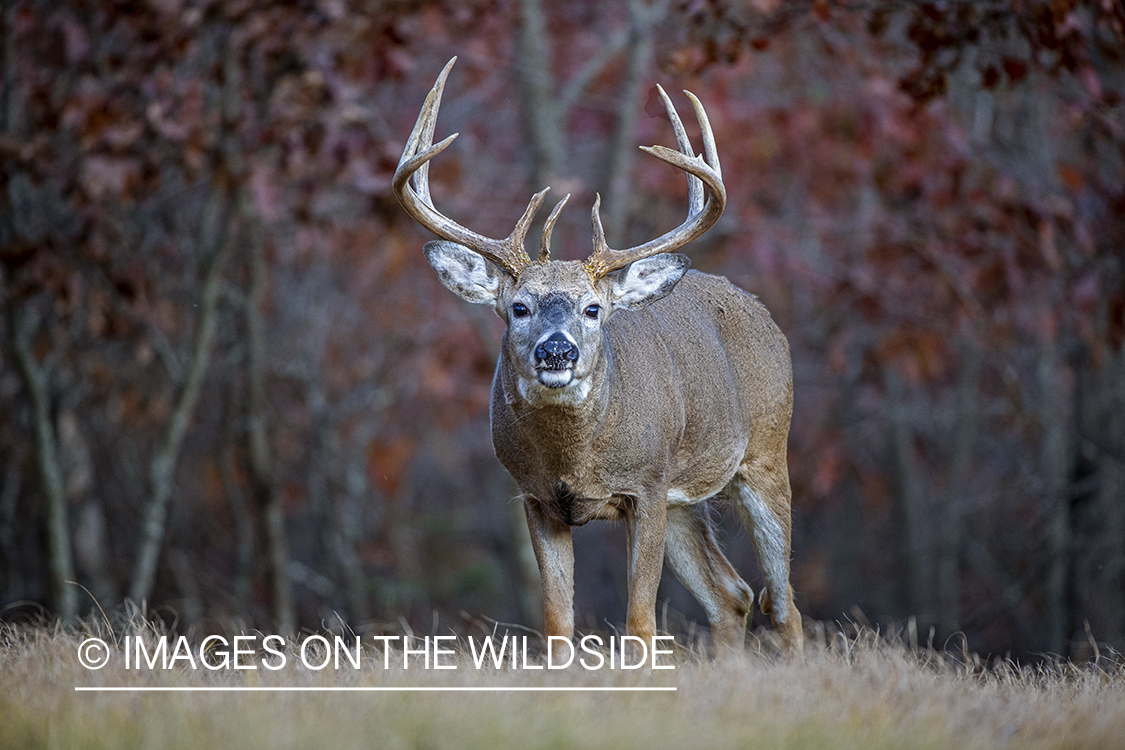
[394,57,726,401]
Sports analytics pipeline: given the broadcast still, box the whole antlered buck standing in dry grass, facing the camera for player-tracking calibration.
[393,57,803,653]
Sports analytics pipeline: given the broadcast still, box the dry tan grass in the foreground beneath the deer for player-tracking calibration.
[0,624,1125,750]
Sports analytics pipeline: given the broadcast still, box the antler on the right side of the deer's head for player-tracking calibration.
[585,85,727,279]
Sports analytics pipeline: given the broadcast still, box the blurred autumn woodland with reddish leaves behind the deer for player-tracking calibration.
[0,0,1125,657]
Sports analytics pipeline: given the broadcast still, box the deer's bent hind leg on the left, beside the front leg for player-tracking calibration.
[664,503,754,652]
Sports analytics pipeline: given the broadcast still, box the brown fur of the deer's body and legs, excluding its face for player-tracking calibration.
[492,262,802,649]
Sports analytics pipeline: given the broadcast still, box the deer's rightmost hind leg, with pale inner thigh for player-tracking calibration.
[731,457,804,652]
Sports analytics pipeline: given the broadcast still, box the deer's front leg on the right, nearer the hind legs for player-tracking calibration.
[626,494,668,644]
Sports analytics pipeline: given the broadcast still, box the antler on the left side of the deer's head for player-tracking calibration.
[394,57,566,275]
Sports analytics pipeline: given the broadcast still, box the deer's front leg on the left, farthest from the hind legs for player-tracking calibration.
[523,496,574,639]
